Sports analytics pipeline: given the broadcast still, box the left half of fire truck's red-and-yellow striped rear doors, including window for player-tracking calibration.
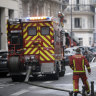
[23,22,40,55]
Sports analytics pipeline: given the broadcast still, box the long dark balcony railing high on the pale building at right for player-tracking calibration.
[66,5,95,13]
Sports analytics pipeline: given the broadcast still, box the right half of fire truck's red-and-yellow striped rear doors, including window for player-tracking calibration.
[38,22,54,61]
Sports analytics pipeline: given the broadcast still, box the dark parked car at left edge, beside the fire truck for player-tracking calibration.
[0,50,8,76]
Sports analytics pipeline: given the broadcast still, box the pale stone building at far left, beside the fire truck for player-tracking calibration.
[0,0,19,50]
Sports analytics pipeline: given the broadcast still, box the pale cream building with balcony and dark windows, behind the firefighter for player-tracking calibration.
[64,0,95,46]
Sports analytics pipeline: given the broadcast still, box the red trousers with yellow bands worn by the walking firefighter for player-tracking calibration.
[73,73,90,93]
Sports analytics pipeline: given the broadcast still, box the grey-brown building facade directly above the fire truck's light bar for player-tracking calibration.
[19,0,65,18]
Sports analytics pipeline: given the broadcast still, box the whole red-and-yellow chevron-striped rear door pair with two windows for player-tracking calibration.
[23,22,54,61]
